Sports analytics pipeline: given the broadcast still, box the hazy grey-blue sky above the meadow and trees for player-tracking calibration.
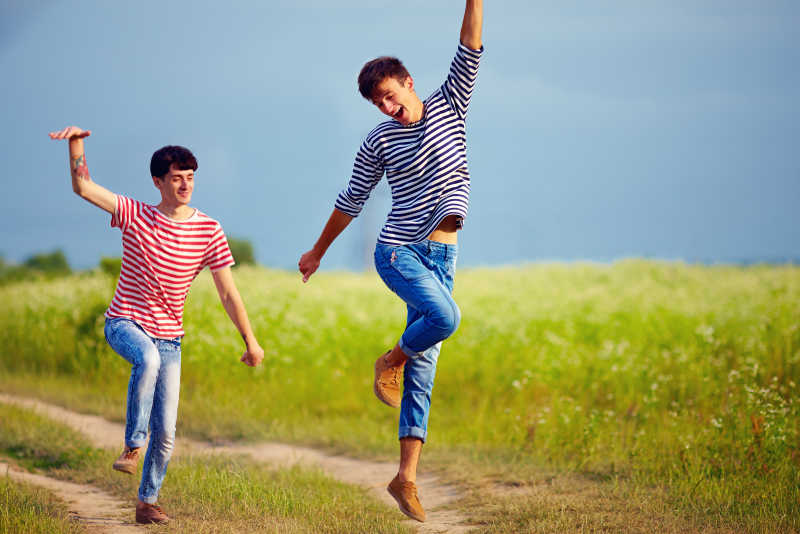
[0,0,800,269]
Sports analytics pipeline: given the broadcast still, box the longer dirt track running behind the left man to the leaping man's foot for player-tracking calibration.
[0,393,470,534]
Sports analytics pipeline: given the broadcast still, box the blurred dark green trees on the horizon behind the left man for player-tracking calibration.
[0,237,256,284]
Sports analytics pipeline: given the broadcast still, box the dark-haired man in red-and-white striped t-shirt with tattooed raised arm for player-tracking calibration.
[50,126,264,523]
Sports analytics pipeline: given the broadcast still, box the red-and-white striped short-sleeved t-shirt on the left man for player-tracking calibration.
[105,195,234,339]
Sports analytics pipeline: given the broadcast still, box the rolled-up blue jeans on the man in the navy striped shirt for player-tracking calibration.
[375,241,461,442]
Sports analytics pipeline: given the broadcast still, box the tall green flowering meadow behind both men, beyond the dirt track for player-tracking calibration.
[0,260,800,532]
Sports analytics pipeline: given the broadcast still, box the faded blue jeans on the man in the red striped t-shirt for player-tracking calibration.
[105,318,181,504]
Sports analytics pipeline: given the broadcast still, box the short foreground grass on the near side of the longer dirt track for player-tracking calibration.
[0,404,408,534]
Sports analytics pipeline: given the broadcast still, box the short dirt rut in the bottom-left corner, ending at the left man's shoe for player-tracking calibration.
[0,460,143,534]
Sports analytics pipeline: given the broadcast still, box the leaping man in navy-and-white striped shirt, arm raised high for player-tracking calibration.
[298,0,483,521]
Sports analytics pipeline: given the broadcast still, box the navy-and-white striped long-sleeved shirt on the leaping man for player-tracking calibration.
[336,44,483,245]
